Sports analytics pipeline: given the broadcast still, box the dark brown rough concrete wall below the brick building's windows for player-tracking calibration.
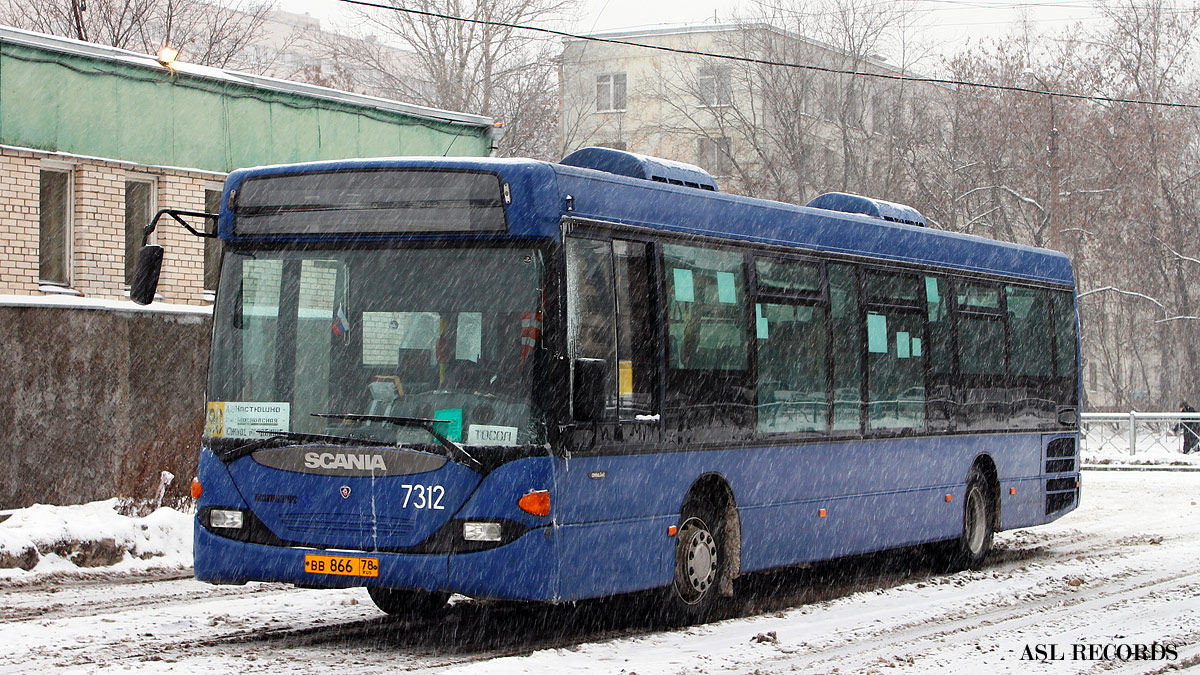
[0,306,211,508]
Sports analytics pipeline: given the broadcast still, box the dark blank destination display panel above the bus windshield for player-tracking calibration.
[234,169,506,237]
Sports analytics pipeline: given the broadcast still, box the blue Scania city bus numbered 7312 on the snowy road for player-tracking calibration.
[133,148,1080,621]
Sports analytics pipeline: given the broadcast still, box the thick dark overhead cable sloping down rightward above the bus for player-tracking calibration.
[338,0,1200,109]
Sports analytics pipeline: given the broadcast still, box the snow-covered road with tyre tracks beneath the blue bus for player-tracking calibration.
[0,472,1200,675]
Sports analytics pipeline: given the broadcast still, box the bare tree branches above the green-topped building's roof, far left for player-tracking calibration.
[0,0,271,70]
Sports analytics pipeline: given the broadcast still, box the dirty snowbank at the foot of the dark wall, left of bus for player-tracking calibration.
[0,498,192,581]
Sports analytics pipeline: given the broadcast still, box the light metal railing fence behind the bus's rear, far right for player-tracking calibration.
[1080,411,1200,455]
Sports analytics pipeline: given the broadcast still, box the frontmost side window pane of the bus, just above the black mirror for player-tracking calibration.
[566,237,618,418]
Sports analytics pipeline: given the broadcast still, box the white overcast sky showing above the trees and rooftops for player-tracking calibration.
[276,0,1094,53]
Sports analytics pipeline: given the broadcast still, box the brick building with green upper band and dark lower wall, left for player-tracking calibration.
[0,28,494,508]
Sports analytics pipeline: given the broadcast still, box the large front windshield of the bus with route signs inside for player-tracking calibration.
[205,246,545,454]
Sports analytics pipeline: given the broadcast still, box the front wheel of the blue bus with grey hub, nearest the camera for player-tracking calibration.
[667,504,727,625]
